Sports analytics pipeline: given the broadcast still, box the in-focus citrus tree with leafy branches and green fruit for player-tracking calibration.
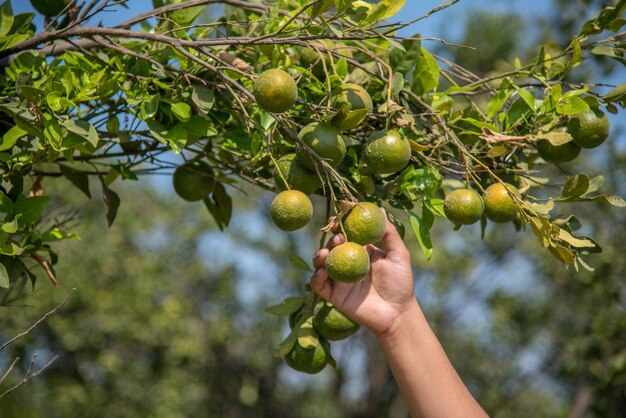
[0,0,626,372]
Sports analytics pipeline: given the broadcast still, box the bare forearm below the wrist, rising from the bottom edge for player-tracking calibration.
[377,301,487,418]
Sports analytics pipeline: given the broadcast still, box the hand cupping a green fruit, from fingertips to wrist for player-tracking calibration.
[311,212,416,336]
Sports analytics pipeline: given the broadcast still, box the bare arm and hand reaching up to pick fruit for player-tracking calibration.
[311,216,487,418]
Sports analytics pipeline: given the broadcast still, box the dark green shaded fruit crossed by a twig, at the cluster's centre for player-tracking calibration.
[296,122,346,170]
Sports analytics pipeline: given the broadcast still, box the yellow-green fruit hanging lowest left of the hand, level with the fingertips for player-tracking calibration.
[270,190,313,231]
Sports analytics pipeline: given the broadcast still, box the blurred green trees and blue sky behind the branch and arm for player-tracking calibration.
[0,0,626,418]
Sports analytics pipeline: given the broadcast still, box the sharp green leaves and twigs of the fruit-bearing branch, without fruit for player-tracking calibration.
[0,0,626,294]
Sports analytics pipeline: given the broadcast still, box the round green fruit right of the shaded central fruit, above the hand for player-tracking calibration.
[363,131,411,174]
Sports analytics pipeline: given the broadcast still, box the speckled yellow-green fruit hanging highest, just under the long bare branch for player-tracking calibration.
[253,69,298,113]
